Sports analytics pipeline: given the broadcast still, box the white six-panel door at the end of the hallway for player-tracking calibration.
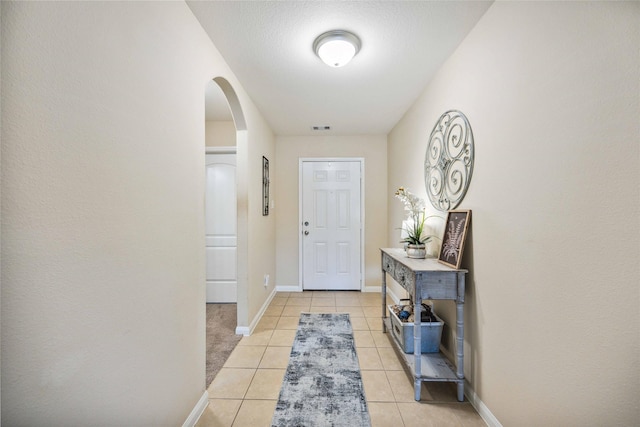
[301,161,362,290]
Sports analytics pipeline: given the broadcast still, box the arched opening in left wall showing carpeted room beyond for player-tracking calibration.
[205,77,247,387]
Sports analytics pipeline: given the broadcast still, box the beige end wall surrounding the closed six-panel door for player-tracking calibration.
[272,135,389,286]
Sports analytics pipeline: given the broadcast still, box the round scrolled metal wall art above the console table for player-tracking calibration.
[424,110,474,211]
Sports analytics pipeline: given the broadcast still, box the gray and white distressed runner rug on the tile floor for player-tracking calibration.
[271,313,371,427]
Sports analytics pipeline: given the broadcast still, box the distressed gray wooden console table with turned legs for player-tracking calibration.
[380,248,467,402]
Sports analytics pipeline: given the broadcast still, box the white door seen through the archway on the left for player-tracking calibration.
[205,154,238,303]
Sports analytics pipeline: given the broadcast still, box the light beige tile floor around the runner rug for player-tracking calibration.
[196,291,486,427]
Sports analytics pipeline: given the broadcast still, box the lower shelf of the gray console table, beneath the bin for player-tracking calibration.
[384,317,464,382]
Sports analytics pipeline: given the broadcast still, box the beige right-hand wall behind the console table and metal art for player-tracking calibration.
[388,2,640,426]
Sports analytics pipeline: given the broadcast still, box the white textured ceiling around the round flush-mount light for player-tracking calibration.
[187,1,492,135]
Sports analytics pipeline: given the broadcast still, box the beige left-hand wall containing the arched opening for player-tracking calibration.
[1,2,275,426]
